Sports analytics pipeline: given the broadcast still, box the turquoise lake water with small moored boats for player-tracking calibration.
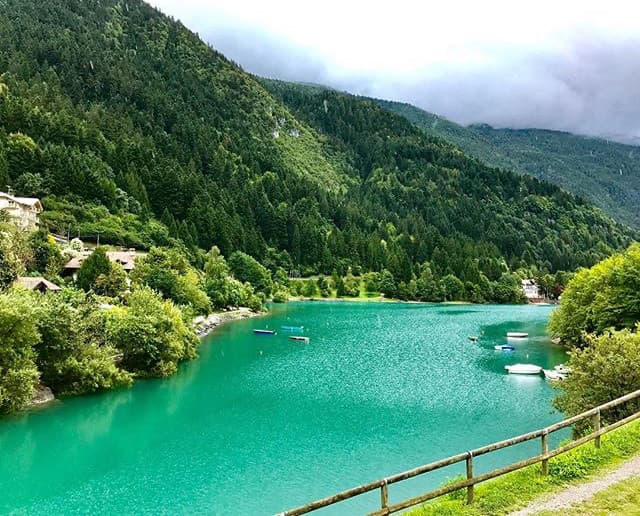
[0,302,566,515]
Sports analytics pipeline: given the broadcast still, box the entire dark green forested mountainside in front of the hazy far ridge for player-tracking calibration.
[0,0,635,299]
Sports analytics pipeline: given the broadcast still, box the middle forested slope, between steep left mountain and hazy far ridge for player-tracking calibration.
[263,80,634,276]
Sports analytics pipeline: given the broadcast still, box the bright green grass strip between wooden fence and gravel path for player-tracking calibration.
[409,421,640,516]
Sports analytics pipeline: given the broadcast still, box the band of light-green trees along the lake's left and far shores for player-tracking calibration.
[0,211,565,414]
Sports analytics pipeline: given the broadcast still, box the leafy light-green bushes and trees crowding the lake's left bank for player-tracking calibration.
[0,234,268,414]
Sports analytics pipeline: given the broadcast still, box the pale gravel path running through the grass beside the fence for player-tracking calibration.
[511,456,640,516]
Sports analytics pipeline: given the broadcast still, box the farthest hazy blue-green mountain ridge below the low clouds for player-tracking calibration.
[375,99,640,228]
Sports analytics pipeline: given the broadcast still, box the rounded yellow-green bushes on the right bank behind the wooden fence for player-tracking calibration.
[549,243,640,428]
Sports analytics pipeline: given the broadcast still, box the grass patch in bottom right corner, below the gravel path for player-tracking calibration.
[536,477,640,516]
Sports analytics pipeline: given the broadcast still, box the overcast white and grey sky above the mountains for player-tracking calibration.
[150,0,640,137]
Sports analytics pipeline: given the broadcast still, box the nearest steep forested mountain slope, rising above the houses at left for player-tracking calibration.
[0,0,350,255]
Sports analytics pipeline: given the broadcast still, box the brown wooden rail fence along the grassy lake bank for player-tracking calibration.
[279,389,640,516]
